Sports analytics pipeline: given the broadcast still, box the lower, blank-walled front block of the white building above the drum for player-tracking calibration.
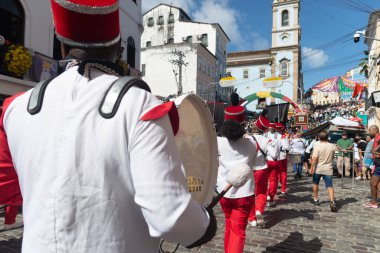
[141,43,216,99]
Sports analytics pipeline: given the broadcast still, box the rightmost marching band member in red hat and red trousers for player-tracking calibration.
[274,122,290,194]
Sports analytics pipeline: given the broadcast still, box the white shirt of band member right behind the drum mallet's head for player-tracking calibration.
[217,137,257,199]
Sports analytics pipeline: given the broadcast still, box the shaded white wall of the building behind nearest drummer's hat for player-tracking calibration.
[0,0,142,98]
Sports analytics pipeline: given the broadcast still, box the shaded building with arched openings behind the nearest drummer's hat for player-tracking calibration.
[0,0,142,104]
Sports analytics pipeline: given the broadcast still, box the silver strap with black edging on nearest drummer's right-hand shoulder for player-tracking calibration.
[99,76,151,119]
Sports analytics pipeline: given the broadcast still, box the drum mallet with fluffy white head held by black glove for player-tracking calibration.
[206,163,252,210]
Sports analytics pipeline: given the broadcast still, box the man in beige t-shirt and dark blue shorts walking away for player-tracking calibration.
[310,131,337,212]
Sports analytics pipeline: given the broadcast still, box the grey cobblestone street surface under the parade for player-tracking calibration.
[0,165,380,253]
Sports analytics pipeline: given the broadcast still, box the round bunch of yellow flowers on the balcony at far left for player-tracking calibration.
[4,45,32,77]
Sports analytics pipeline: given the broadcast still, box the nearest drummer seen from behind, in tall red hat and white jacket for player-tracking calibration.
[0,0,216,253]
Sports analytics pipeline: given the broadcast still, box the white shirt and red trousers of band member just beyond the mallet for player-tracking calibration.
[217,137,257,253]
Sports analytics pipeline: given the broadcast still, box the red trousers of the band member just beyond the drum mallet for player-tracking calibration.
[220,196,255,253]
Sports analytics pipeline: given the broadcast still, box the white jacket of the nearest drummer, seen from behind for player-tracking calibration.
[4,67,209,253]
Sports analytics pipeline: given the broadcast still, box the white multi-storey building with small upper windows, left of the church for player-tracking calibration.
[141,4,232,101]
